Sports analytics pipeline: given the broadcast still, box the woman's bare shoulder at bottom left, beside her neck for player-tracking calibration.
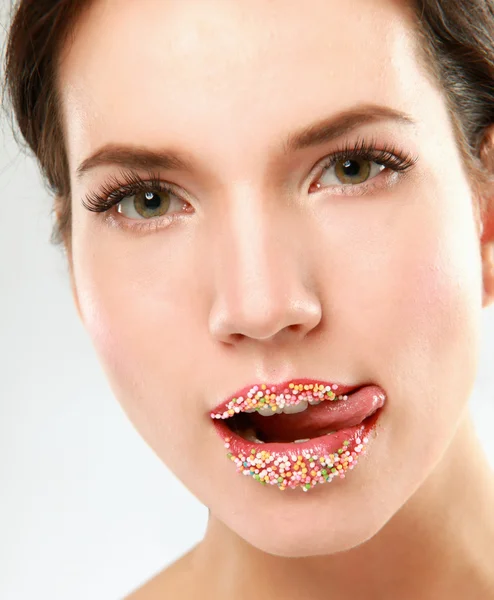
[123,547,201,600]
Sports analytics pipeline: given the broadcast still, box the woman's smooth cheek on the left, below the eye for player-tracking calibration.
[70,228,206,462]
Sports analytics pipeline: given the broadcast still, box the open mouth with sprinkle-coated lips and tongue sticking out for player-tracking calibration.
[211,380,386,491]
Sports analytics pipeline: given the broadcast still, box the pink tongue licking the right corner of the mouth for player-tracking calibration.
[249,385,384,442]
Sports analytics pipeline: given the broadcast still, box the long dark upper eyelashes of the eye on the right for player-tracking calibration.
[322,138,418,172]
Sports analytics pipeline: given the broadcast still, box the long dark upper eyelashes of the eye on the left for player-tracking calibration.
[82,171,176,213]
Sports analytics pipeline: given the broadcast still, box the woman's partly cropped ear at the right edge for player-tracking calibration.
[480,124,494,308]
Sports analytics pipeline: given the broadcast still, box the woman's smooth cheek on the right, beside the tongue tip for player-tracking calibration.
[359,185,482,487]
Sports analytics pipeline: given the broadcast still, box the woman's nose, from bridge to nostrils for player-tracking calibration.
[209,195,322,344]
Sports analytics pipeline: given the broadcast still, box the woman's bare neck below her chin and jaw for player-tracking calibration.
[196,413,494,600]
